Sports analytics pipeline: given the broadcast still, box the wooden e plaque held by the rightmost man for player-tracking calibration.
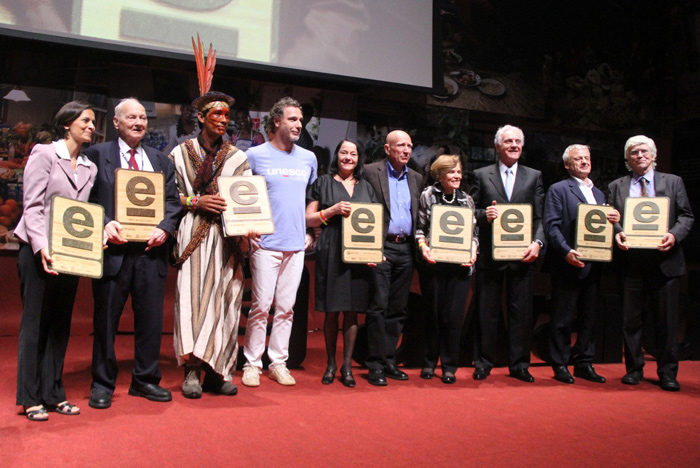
[622,197,671,249]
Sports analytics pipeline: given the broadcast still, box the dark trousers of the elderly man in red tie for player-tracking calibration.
[92,249,165,394]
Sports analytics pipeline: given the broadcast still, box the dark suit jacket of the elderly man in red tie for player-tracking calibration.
[85,140,182,277]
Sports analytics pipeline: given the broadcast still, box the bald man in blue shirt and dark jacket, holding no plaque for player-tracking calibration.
[365,130,422,386]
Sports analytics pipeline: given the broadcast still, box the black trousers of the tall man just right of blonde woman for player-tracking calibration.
[474,266,534,371]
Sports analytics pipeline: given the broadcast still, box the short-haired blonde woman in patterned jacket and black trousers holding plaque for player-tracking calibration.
[416,155,479,384]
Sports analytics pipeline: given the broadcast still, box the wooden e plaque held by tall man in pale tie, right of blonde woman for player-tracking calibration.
[492,203,532,260]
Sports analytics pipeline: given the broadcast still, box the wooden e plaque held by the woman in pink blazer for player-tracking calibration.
[49,196,105,278]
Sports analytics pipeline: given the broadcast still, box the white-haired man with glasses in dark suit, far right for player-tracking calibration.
[608,135,694,391]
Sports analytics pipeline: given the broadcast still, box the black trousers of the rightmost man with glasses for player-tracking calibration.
[622,265,680,379]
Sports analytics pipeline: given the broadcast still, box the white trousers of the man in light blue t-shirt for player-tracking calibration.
[243,249,304,369]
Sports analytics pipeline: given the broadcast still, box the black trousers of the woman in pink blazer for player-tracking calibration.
[17,244,78,407]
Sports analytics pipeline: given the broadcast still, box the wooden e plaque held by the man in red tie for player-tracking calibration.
[114,169,165,242]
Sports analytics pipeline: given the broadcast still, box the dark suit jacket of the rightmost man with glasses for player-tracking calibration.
[608,171,695,278]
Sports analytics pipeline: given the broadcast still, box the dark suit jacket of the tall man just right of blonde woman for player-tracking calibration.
[469,163,545,270]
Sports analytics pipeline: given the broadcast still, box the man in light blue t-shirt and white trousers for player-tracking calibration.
[242,97,317,387]
